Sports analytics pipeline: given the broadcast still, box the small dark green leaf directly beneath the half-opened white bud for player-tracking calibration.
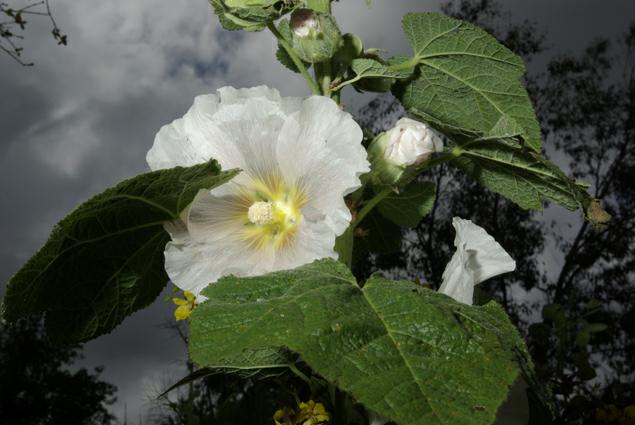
[377,182,435,227]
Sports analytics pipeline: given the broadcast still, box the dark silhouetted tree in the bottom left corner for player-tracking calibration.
[0,319,116,425]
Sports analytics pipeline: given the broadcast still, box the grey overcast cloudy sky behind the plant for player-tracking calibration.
[0,0,635,423]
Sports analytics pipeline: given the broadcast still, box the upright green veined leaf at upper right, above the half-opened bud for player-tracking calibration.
[393,13,541,152]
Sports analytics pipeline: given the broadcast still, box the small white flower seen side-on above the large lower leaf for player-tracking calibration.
[439,217,516,305]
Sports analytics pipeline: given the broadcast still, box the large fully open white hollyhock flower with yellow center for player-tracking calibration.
[146,86,369,295]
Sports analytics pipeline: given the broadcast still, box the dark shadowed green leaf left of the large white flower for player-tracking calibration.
[3,161,237,343]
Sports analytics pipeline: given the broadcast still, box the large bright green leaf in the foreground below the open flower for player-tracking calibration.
[190,260,527,425]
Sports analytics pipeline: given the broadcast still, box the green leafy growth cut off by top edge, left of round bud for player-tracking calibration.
[211,0,300,31]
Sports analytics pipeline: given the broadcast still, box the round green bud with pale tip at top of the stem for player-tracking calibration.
[289,9,342,63]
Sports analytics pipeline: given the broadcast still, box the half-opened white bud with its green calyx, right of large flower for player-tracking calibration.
[368,118,443,184]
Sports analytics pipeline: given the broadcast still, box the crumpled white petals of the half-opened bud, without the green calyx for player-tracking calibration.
[384,118,443,166]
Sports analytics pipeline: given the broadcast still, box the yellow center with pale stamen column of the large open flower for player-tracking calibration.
[240,177,306,249]
